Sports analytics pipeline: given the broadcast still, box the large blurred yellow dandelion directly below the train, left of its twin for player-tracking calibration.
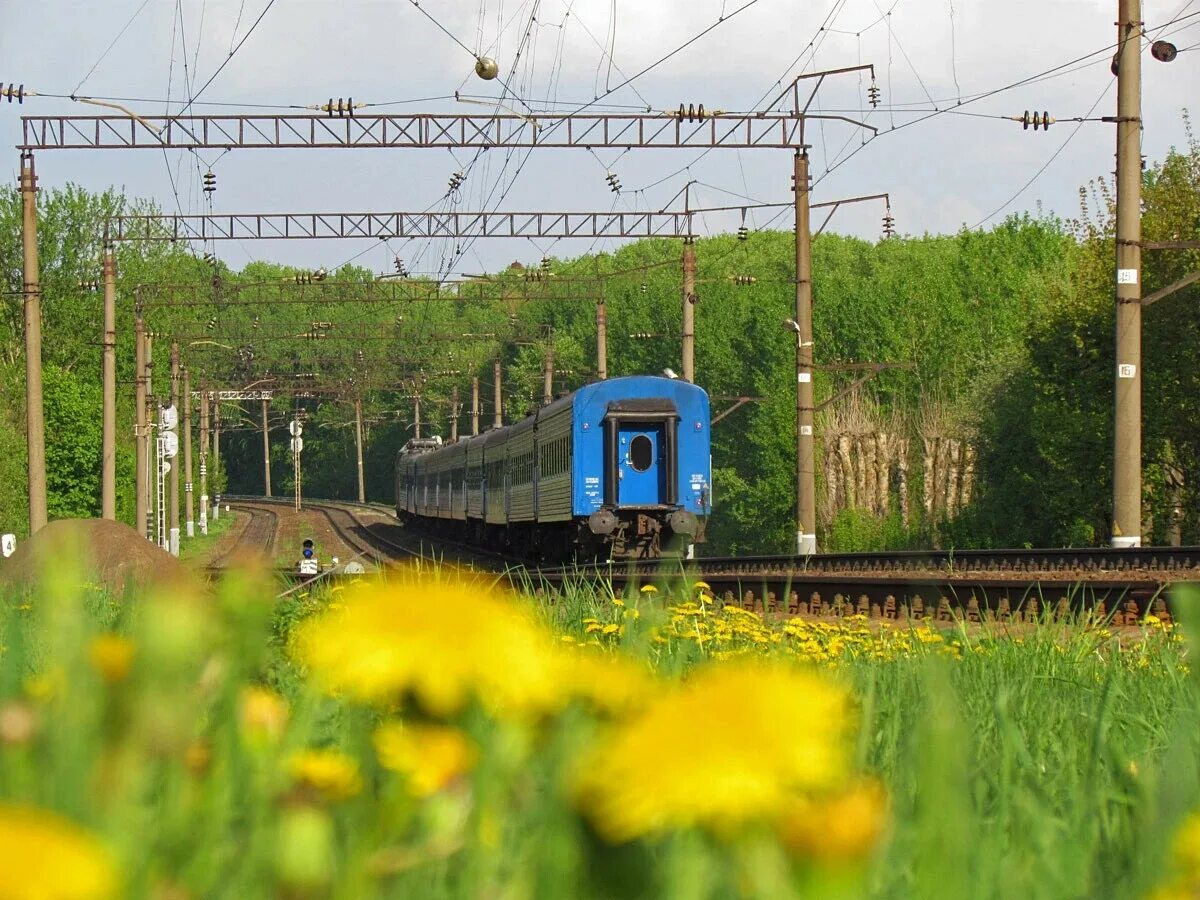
[295,581,578,716]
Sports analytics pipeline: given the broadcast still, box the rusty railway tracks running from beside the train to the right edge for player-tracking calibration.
[218,498,1200,624]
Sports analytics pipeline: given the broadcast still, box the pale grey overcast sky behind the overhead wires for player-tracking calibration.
[0,0,1200,272]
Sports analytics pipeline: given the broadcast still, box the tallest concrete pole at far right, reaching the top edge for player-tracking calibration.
[1112,0,1142,547]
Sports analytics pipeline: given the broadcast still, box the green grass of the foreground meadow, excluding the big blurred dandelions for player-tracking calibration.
[0,561,1200,900]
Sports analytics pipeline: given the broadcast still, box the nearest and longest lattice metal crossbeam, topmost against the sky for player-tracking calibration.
[20,113,806,151]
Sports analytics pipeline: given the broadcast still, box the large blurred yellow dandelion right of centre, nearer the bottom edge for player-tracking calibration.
[572,665,848,842]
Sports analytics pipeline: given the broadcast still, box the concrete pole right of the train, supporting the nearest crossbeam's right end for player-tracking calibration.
[792,151,817,556]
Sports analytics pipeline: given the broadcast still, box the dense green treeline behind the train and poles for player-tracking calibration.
[0,132,1200,552]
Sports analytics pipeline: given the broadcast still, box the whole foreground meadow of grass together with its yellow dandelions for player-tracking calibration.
[0,554,1200,900]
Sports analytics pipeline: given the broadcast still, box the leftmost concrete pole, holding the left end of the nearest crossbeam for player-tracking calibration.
[20,151,48,534]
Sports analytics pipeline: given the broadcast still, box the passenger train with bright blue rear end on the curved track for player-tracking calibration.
[396,376,712,560]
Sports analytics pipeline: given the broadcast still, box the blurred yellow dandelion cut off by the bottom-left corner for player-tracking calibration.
[0,804,118,900]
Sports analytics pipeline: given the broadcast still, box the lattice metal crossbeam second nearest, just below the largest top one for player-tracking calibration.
[108,212,692,241]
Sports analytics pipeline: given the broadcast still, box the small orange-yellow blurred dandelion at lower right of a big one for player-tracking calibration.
[778,781,887,864]
